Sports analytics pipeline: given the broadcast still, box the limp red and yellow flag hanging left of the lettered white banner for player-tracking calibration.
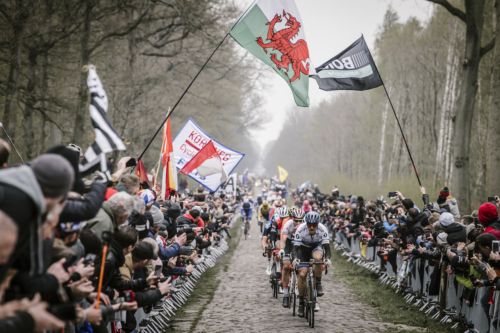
[161,118,179,200]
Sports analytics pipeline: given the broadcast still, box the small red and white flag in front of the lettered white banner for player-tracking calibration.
[181,140,227,183]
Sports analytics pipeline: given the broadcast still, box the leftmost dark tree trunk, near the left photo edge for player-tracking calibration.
[3,25,24,145]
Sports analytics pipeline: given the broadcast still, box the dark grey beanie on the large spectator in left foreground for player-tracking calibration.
[30,154,75,198]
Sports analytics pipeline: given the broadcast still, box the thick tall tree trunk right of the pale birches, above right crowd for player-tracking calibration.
[452,0,485,212]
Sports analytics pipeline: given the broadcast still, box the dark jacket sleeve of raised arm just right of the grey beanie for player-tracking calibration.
[59,182,106,222]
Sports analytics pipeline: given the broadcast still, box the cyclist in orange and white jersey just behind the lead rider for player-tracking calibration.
[280,207,306,308]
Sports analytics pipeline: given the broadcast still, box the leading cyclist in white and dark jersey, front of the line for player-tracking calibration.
[293,212,332,317]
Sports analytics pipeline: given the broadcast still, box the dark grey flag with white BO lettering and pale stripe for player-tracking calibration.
[311,37,382,91]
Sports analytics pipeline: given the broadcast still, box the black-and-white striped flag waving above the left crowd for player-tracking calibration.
[79,66,127,176]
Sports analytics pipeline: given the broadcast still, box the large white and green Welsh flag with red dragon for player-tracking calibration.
[229,0,315,107]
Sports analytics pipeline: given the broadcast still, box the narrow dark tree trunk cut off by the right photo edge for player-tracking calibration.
[486,0,500,195]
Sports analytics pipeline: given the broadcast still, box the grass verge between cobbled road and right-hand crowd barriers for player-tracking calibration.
[332,246,463,333]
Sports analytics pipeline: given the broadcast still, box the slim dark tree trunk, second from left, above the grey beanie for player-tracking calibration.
[22,44,37,161]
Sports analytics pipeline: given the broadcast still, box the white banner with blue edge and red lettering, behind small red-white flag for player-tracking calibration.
[173,118,245,192]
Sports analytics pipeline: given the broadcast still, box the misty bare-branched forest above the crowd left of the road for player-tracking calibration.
[0,0,267,176]
